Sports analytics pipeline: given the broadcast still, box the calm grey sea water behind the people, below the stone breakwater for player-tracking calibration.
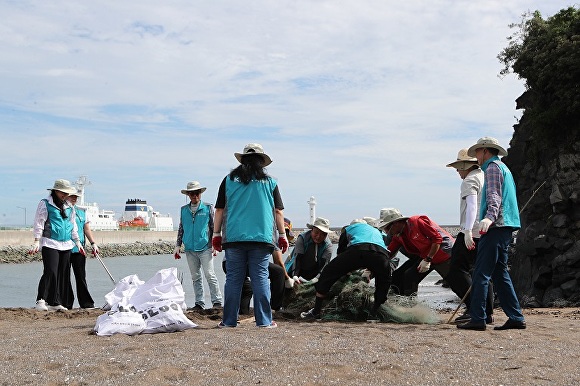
[0,249,459,309]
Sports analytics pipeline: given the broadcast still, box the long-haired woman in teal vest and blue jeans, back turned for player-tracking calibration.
[212,143,288,328]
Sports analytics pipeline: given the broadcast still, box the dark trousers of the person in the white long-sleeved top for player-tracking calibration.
[445,233,493,316]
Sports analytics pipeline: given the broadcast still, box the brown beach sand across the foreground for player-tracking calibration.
[0,308,580,385]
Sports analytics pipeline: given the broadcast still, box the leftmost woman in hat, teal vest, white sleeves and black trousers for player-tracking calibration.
[29,180,84,311]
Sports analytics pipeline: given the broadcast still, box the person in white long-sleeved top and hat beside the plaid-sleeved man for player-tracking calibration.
[445,149,493,323]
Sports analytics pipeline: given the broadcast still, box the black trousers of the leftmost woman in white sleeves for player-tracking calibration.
[36,247,71,306]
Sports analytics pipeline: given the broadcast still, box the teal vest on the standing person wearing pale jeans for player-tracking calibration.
[181,202,211,252]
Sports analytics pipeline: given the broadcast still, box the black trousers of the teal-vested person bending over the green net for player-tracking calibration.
[314,244,392,310]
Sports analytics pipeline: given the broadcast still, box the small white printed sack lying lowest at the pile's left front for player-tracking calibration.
[94,305,147,336]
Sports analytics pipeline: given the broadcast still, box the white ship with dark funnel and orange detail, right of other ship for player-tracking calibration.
[119,198,173,231]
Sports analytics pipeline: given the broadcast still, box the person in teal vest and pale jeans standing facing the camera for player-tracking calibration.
[173,181,222,310]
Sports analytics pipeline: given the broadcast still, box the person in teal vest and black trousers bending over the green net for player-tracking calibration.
[300,220,392,320]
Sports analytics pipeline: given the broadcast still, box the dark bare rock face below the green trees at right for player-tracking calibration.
[503,122,580,307]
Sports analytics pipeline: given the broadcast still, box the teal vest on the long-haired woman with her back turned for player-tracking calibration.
[222,176,277,245]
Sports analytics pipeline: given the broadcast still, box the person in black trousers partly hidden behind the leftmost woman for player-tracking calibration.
[64,191,99,309]
